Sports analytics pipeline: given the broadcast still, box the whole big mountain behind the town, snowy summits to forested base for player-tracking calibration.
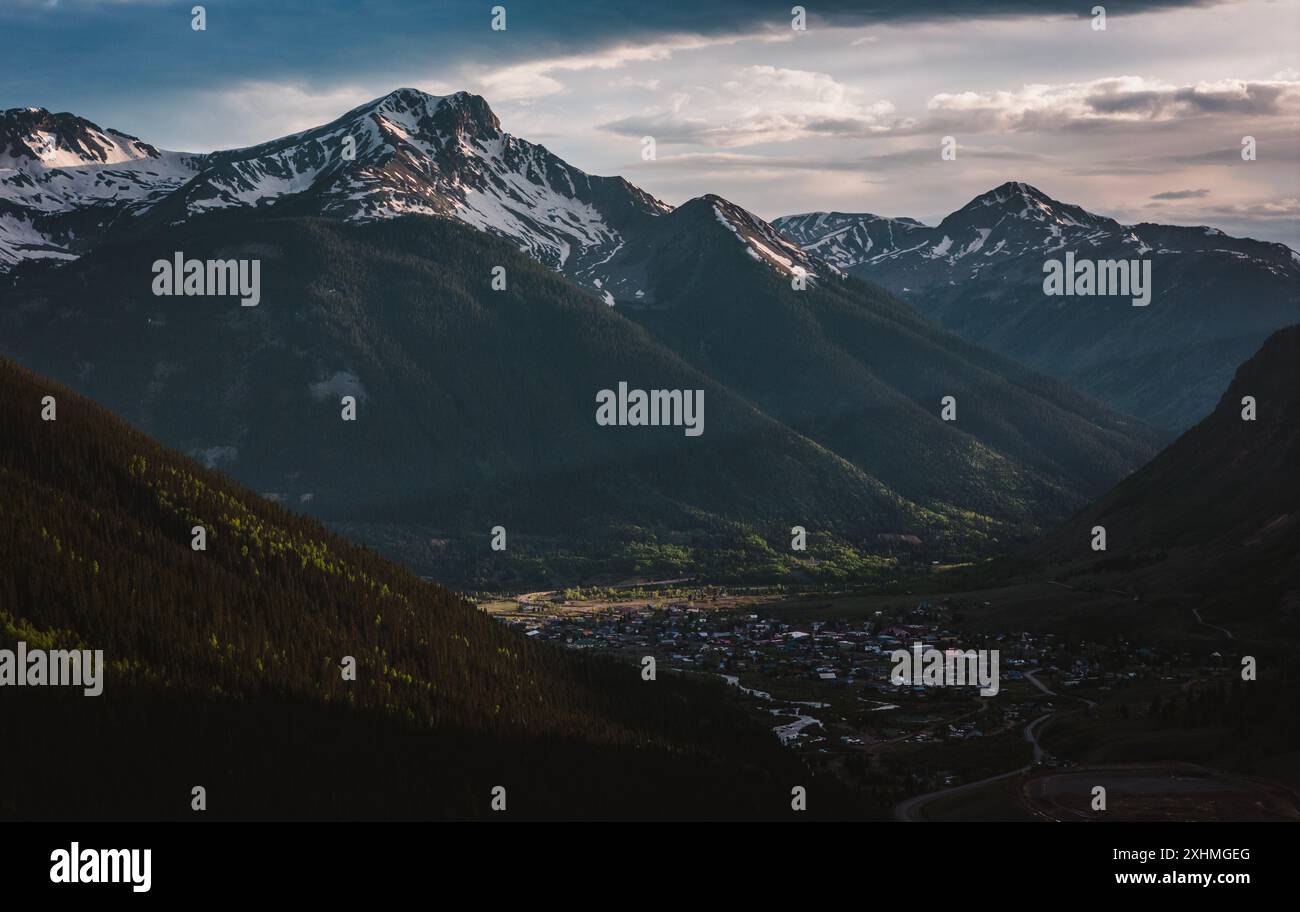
[0,90,1160,582]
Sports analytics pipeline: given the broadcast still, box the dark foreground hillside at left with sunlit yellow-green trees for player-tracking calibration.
[0,359,857,820]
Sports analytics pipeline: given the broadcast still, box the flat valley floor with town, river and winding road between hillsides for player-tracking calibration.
[480,579,1300,821]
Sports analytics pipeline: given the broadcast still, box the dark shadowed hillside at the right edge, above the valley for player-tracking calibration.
[1026,326,1300,638]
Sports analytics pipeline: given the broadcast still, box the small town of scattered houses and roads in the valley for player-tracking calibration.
[481,581,1297,820]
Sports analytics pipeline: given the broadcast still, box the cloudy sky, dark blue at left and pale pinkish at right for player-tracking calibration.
[0,0,1300,248]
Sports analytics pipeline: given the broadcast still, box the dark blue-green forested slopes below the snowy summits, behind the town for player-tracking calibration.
[0,209,1153,587]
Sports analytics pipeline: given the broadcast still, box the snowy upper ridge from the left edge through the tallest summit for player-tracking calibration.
[0,88,670,291]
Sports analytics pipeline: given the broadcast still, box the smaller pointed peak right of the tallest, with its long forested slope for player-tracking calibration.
[598,197,1154,530]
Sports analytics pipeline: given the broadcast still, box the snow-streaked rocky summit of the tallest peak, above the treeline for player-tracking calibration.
[154,88,671,274]
